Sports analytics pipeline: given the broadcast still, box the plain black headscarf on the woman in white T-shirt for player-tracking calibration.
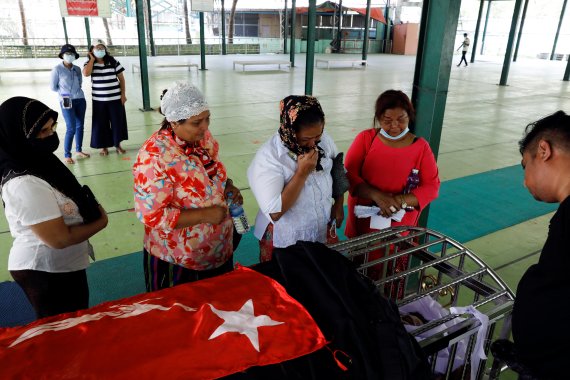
[0,96,101,223]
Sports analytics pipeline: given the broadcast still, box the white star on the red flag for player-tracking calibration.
[208,299,283,352]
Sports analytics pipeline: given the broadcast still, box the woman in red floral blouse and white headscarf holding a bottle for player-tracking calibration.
[133,82,243,291]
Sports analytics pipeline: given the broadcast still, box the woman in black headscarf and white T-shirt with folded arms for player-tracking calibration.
[0,97,107,318]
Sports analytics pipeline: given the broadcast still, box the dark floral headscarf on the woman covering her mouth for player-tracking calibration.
[279,95,325,170]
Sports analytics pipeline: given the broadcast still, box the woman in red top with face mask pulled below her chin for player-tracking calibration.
[345,90,440,237]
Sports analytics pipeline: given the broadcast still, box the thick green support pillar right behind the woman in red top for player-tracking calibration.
[412,0,461,226]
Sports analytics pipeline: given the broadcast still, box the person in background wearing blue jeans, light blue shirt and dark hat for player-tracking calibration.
[51,44,89,164]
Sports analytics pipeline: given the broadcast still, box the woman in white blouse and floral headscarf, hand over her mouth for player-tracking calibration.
[247,95,344,262]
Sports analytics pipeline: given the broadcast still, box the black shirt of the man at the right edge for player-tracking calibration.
[513,197,570,379]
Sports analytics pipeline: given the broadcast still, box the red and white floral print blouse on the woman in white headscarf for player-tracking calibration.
[133,128,233,270]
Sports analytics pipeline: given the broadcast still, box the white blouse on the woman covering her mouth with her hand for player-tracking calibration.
[247,132,338,248]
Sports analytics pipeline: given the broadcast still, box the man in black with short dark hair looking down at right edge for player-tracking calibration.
[513,111,570,379]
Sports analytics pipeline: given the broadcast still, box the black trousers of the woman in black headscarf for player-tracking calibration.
[10,269,89,319]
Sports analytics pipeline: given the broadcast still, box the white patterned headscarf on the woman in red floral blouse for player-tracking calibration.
[160,82,210,122]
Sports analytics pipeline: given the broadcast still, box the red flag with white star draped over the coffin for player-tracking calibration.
[0,267,326,380]
